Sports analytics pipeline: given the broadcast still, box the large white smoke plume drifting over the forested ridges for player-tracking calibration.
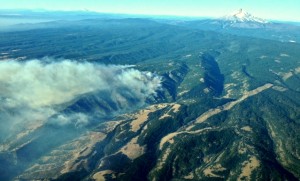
[0,59,161,135]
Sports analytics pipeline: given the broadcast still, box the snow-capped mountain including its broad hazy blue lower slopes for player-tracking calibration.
[176,9,300,43]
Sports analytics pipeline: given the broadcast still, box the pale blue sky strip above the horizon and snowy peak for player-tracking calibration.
[0,0,300,21]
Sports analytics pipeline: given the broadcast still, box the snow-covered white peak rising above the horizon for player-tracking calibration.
[220,9,269,24]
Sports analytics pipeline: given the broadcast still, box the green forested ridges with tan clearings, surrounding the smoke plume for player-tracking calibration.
[0,15,300,181]
